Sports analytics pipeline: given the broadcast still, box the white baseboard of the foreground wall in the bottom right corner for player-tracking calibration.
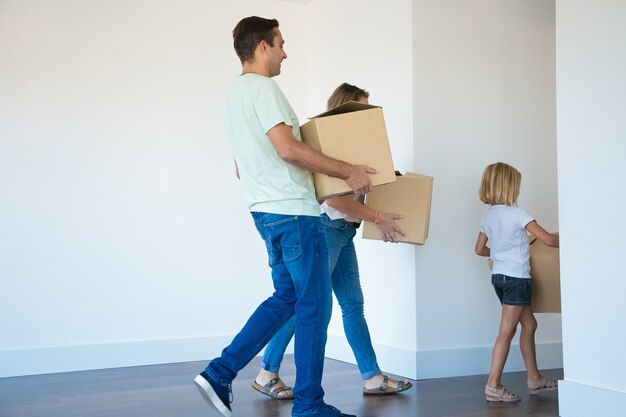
[559,381,626,417]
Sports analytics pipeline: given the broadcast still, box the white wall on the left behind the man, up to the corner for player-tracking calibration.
[0,0,305,375]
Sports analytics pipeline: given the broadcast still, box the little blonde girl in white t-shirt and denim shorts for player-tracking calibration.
[475,162,559,402]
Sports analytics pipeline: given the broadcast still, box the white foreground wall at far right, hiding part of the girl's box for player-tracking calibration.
[556,0,626,417]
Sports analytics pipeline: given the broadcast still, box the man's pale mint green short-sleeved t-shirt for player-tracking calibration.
[226,73,320,216]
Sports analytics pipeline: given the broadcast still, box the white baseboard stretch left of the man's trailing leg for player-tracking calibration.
[0,336,233,377]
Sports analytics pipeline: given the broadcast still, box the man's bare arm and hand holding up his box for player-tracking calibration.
[267,123,378,195]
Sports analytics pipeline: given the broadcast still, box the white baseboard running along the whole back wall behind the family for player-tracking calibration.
[0,335,563,379]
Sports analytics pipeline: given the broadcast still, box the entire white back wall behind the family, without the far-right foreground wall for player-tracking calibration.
[0,0,560,378]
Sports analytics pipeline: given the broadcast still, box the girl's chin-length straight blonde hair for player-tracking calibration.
[478,162,522,206]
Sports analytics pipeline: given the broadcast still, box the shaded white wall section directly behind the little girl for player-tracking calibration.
[413,0,562,378]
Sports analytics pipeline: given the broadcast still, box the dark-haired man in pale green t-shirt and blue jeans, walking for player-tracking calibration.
[194,16,376,417]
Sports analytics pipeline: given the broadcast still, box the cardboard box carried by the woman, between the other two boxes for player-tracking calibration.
[363,172,433,245]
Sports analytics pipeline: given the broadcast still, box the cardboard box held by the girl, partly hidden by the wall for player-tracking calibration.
[530,236,561,313]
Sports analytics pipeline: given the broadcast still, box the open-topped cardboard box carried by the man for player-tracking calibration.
[300,101,396,200]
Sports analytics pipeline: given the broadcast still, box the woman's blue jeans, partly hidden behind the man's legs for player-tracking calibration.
[261,214,381,380]
